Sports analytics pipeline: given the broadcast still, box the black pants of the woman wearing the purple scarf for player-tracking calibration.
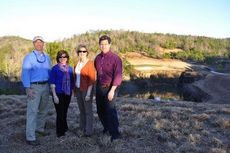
[54,93,71,137]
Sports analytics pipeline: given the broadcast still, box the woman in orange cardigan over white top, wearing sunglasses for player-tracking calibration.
[74,44,96,136]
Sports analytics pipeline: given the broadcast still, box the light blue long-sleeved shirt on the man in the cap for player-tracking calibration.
[21,50,51,88]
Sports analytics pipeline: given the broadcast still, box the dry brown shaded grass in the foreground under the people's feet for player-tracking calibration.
[0,95,230,153]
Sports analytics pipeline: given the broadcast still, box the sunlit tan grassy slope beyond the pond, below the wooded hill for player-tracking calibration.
[121,52,191,80]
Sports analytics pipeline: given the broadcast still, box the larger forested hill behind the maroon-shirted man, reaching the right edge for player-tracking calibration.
[59,31,230,61]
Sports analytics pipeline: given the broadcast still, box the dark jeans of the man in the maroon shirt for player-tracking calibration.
[96,84,120,137]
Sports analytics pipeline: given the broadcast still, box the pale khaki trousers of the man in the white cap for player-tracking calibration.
[26,83,50,141]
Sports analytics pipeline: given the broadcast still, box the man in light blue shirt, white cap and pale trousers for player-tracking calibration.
[21,36,51,146]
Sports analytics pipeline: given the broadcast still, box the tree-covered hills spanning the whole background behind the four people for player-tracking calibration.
[0,30,230,79]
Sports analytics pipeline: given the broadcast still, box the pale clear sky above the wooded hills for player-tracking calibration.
[0,0,230,41]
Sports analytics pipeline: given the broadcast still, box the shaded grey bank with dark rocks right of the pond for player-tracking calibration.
[178,71,230,103]
